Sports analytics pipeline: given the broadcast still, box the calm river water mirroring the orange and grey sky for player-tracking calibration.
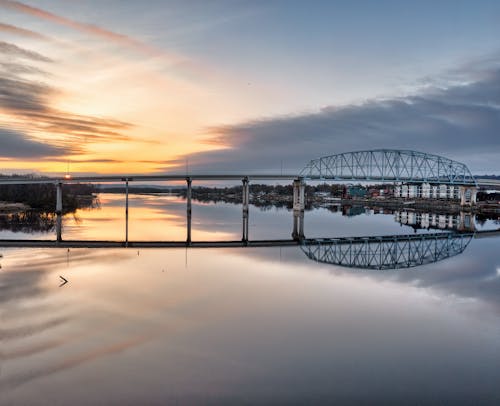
[0,195,500,405]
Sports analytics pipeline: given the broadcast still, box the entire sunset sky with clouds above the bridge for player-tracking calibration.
[0,0,500,175]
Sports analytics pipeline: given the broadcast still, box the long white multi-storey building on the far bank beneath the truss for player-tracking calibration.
[394,182,477,205]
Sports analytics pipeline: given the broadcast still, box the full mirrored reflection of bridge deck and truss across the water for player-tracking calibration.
[0,229,500,269]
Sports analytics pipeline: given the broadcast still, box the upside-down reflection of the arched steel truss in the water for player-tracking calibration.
[301,233,474,269]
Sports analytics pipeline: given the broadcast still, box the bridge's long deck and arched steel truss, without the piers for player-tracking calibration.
[0,149,478,186]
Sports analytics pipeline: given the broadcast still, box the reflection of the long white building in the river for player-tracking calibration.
[394,211,475,231]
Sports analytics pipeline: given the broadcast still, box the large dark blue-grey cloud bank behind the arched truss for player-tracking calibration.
[167,62,500,173]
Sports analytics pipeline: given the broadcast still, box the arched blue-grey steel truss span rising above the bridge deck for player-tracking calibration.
[300,149,476,185]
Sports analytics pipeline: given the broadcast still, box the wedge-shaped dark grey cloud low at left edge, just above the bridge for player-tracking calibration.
[0,127,71,158]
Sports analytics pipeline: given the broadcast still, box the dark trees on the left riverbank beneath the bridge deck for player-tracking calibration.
[0,183,94,212]
